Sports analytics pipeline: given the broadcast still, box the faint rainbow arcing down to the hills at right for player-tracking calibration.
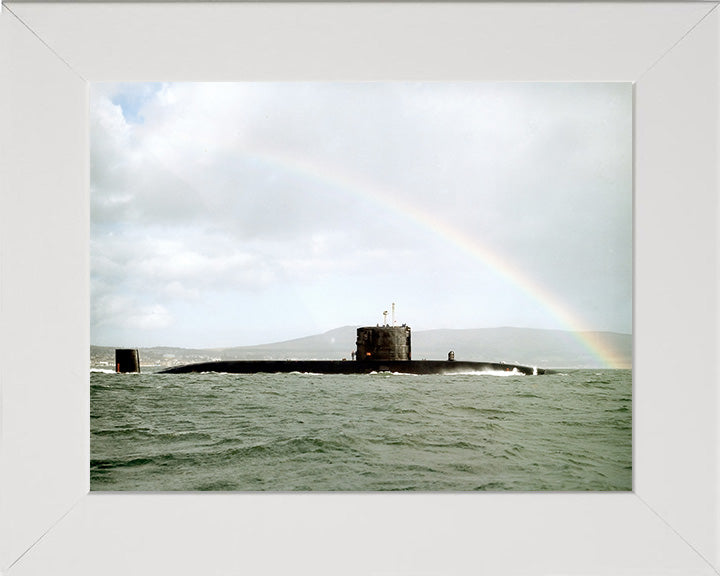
[243,149,624,368]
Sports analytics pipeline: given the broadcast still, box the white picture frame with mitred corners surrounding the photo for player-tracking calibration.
[0,2,720,576]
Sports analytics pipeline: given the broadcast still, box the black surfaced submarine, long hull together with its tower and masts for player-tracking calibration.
[141,310,552,375]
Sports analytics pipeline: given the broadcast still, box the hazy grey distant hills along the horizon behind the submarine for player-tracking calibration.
[90,326,632,368]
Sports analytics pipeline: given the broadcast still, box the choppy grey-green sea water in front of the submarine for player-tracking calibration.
[90,369,632,492]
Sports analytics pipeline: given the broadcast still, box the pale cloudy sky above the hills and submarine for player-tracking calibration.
[90,82,632,348]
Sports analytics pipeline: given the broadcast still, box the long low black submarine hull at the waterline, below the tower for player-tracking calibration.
[160,360,551,375]
